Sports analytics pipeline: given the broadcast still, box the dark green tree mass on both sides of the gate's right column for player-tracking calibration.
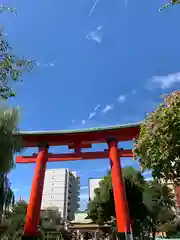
[88,167,176,239]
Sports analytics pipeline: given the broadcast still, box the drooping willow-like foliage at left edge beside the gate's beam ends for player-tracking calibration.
[0,106,22,173]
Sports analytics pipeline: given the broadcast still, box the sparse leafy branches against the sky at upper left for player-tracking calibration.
[0,5,35,99]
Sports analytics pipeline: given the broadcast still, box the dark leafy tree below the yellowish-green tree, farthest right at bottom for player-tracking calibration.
[143,181,176,239]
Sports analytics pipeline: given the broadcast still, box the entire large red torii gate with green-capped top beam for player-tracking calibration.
[15,123,141,240]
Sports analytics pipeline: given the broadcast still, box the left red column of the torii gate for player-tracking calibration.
[23,147,48,239]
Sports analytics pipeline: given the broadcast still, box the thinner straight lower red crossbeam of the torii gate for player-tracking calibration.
[16,150,133,163]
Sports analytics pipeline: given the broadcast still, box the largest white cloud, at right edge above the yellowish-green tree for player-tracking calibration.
[147,72,180,90]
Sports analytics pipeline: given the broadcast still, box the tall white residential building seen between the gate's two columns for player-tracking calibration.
[41,168,80,220]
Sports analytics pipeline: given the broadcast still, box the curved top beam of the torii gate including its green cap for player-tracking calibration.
[14,123,141,147]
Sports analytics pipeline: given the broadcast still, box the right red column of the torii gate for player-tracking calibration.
[108,139,130,239]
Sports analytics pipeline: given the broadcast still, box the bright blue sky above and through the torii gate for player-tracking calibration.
[1,0,180,208]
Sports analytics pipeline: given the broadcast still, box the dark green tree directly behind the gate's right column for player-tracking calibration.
[88,167,148,238]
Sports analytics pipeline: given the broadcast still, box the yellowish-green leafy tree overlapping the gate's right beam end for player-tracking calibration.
[134,91,180,184]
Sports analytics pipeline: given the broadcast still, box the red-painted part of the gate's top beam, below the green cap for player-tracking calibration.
[17,126,139,147]
